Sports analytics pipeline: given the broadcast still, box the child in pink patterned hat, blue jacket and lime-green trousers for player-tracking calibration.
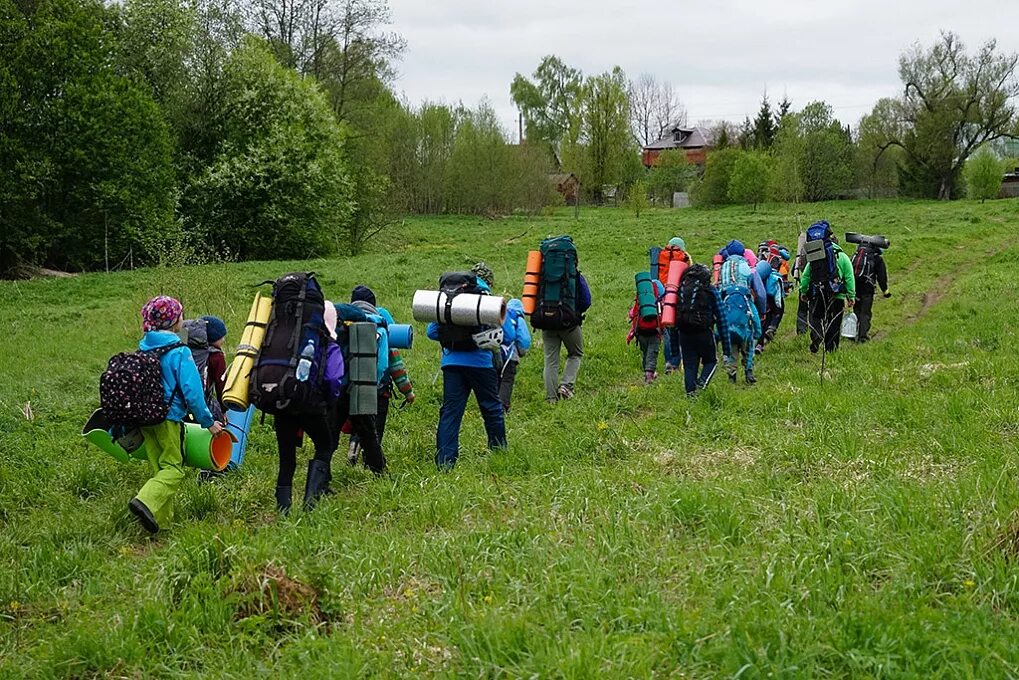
[123,296,223,533]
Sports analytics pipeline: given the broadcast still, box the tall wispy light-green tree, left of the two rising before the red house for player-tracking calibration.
[510,54,584,160]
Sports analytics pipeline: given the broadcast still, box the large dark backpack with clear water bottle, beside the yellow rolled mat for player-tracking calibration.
[249,272,329,414]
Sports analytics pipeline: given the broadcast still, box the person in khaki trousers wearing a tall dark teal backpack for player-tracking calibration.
[531,237,591,403]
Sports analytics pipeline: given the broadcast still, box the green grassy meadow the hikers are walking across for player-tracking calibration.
[0,201,1019,678]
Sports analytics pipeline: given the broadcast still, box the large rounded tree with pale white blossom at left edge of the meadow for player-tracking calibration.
[183,39,354,259]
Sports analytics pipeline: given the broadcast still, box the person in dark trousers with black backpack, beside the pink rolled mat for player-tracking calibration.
[676,264,735,396]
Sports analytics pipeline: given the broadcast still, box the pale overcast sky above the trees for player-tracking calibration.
[389,0,1019,138]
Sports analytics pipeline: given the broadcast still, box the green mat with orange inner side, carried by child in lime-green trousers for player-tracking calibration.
[82,409,233,471]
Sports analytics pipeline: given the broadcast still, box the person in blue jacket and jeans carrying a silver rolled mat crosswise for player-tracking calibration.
[428,262,514,470]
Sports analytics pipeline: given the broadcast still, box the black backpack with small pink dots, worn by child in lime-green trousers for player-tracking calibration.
[99,343,182,427]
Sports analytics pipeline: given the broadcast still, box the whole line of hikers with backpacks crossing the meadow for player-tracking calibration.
[100,222,890,532]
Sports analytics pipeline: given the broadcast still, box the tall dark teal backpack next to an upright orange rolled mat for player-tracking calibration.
[531,237,581,330]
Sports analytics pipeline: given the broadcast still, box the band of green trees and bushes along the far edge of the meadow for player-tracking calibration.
[0,0,1019,275]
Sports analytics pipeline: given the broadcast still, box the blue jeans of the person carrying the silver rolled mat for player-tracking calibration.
[435,366,506,469]
